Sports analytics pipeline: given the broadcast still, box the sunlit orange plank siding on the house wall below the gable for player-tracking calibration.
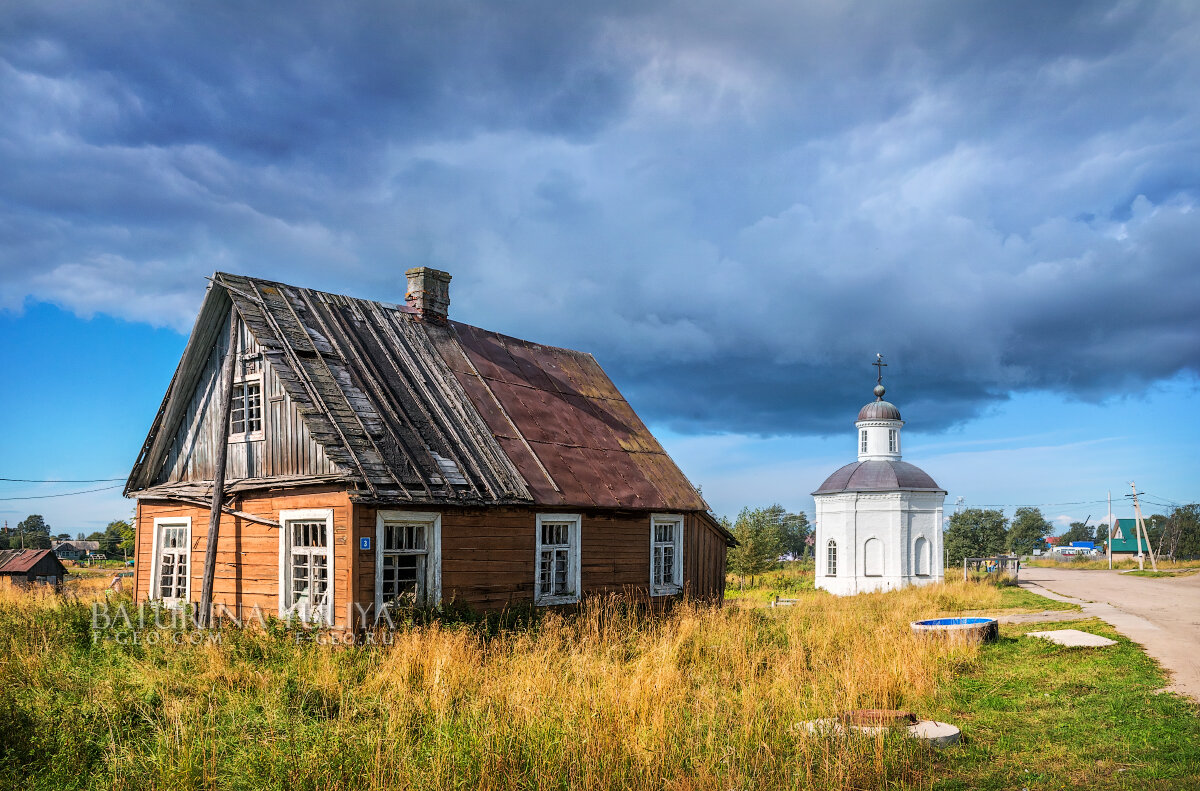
[134,489,352,625]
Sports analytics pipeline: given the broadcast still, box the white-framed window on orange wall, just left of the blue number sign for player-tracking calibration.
[280,509,334,625]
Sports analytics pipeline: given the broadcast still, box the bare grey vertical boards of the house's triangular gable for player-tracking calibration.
[154,324,338,484]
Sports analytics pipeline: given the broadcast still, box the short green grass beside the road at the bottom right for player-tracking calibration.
[923,619,1200,791]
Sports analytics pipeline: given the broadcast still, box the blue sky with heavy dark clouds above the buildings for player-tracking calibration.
[0,0,1200,532]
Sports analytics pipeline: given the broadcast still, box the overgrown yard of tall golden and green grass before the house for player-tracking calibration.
[0,582,1200,791]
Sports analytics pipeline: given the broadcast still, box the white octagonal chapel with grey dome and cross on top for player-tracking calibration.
[812,355,946,595]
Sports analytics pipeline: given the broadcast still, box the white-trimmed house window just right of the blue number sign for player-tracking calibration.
[376,511,442,617]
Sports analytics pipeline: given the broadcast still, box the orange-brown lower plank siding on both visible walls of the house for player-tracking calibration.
[134,489,726,627]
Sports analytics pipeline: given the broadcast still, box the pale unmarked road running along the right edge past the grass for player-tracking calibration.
[1021,564,1200,701]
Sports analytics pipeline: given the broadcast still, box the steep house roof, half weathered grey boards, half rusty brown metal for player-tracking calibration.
[126,272,707,511]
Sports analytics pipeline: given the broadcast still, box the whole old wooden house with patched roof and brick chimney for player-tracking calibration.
[125,268,732,627]
